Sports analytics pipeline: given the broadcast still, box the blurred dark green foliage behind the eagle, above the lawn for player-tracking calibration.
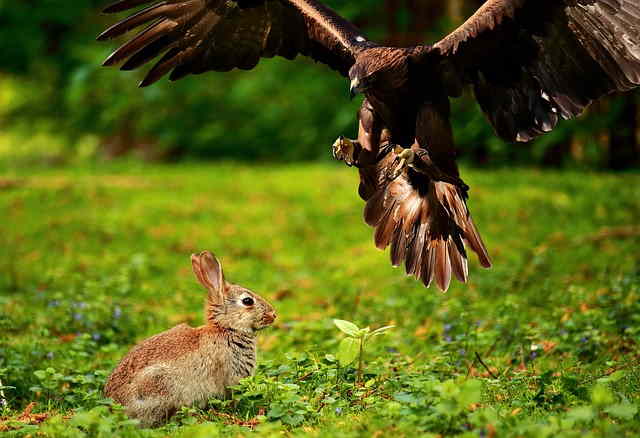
[0,0,640,169]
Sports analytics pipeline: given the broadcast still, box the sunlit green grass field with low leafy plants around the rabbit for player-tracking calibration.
[0,163,640,438]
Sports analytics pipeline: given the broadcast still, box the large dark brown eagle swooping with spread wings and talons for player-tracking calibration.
[98,0,640,291]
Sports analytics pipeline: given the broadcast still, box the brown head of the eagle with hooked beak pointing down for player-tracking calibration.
[349,47,408,99]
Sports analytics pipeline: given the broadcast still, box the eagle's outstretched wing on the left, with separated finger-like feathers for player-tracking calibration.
[98,0,372,86]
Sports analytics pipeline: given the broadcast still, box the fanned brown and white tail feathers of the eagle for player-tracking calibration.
[364,170,491,291]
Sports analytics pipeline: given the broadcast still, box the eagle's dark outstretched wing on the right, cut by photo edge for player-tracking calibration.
[416,0,640,141]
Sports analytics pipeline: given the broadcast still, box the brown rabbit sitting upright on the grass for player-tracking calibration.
[104,251,276,426]
